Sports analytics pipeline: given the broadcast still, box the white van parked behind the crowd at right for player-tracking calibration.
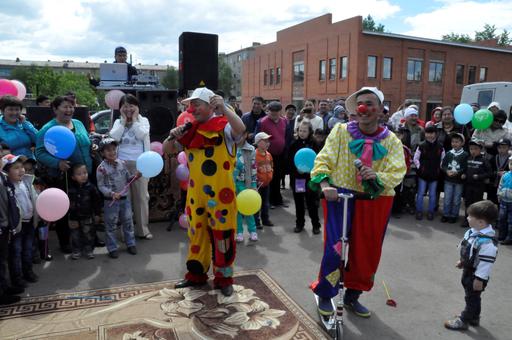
[460,81,512,121]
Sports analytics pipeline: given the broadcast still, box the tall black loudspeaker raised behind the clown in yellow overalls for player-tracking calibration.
[179,32,219,91]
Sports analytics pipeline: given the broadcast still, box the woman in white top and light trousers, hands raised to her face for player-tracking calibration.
[110,94,153,240]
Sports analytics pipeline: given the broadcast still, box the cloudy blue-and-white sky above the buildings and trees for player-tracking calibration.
[0,0,512,65]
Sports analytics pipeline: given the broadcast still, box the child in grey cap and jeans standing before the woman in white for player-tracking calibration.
[96,138,137,259]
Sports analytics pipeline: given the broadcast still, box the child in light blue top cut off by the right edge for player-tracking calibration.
[498,157,512,245]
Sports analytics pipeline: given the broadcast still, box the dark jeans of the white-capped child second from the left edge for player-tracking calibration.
[9,221,34,283]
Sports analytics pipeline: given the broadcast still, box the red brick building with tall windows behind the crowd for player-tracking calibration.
[242,14,512,118]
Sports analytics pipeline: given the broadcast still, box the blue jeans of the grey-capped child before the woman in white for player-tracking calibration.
[103,199,135,253]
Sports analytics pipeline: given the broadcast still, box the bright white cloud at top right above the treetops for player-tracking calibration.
[404,0,512,39]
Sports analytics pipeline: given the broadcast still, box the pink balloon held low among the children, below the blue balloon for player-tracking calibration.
[36,188,69,222]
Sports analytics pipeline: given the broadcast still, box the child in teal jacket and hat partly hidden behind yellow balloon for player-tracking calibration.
[233,132,258,243]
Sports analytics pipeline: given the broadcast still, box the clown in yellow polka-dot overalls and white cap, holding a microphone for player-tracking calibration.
[170,87,245,296]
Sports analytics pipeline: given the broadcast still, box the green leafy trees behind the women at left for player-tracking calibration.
[11,65,98,110]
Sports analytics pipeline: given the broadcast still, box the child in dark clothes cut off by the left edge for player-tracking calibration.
[0,144,25,306]
